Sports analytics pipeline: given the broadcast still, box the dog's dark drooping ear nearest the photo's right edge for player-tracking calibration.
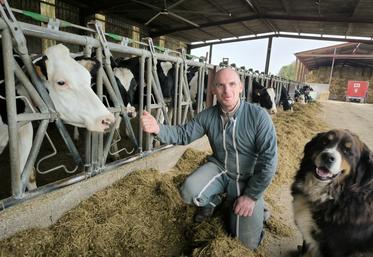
[351,144,373,197]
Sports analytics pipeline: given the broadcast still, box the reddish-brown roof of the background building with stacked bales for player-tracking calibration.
[295,43,373,70]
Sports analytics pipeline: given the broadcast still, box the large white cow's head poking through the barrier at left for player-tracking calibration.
[36,44,115,132]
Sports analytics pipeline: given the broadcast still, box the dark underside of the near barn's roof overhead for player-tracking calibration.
[60,0,373,46]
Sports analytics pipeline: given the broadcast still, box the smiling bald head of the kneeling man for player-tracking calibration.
[212,68,243,112]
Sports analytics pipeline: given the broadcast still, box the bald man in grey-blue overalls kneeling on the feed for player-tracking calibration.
[141,68,277,249]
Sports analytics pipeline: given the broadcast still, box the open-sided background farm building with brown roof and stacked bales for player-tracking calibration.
[295,43,373,103]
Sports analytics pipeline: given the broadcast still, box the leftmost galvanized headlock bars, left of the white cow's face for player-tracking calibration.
[0,1,81,197]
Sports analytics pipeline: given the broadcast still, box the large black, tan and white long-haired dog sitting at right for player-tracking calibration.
[291,129,373,257]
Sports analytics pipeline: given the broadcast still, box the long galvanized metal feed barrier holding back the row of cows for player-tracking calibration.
[0,2,308,210]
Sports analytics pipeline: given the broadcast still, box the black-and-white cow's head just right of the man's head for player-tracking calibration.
[245,77,277,114]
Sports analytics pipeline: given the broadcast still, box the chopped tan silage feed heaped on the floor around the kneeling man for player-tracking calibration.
[0,104,325,257]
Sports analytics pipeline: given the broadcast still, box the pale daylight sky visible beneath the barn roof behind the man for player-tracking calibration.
[191,38,343,74]
